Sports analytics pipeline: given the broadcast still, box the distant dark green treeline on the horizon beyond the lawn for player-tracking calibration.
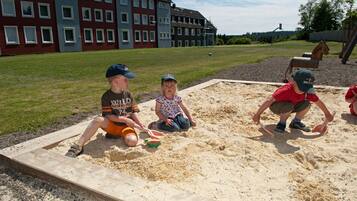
[217,31,297,45]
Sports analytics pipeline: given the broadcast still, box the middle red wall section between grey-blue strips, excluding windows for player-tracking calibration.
[78,0,119,51]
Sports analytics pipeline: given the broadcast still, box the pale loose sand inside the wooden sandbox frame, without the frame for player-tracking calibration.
[52,82,357,201]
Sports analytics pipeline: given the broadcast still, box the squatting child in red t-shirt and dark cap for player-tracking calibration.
[253,70,333,133]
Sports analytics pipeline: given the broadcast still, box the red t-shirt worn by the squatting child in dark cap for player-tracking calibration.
[273,83,319,105]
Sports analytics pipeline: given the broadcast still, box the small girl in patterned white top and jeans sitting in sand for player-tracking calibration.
[155,74,196,132]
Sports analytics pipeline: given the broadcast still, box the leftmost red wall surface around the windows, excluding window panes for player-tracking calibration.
[0,0,59,55]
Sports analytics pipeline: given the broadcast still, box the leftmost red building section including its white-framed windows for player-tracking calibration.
[0,0,59,55]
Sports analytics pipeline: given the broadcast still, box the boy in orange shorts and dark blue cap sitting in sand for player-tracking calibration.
[66,64,150,157]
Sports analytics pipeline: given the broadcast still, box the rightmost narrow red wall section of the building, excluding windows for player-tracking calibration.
[132,0,158,48]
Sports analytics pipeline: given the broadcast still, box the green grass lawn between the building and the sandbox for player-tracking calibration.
[0,41,357,135]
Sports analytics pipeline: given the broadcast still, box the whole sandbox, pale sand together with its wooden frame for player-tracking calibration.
[0,80,357,200]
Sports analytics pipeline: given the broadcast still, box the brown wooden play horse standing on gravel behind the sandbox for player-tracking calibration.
[284,41,330,82]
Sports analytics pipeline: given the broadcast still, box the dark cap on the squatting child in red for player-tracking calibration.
[292,69,315,92]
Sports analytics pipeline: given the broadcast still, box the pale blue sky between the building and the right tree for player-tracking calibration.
[173,0,308,35]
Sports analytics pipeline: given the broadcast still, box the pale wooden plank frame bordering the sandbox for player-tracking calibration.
[0,79,347,201]
